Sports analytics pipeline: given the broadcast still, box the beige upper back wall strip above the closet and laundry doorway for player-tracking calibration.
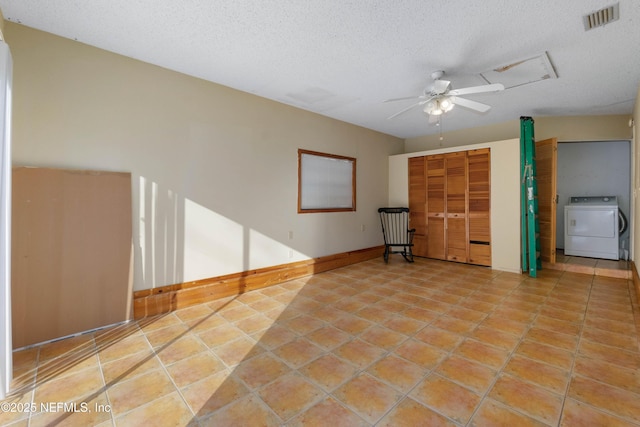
[405,115,631,153]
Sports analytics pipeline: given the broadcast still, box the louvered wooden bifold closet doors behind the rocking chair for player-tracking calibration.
[409,148,491,266]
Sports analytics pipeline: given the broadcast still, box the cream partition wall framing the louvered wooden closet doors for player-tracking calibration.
[389,139,521,273]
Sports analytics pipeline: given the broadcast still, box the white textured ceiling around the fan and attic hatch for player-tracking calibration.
[0,0,640,138]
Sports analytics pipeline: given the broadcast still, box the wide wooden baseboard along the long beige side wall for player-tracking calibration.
[133,246,384,319]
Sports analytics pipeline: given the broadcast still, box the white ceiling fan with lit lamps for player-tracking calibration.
[384,71,504,119]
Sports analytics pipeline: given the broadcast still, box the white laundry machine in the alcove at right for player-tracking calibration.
[564,196,619,260]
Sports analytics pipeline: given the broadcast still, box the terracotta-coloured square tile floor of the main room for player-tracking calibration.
[0,256,640,427]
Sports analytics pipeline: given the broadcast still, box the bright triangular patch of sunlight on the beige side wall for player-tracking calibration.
[133,176,308,290]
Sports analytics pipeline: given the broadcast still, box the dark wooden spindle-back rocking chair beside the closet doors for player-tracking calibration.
[378,208,416,262]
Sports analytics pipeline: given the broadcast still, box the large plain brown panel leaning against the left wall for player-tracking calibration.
[11,168,132,348]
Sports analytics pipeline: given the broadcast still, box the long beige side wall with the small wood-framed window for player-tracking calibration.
[5,23,403,290]
